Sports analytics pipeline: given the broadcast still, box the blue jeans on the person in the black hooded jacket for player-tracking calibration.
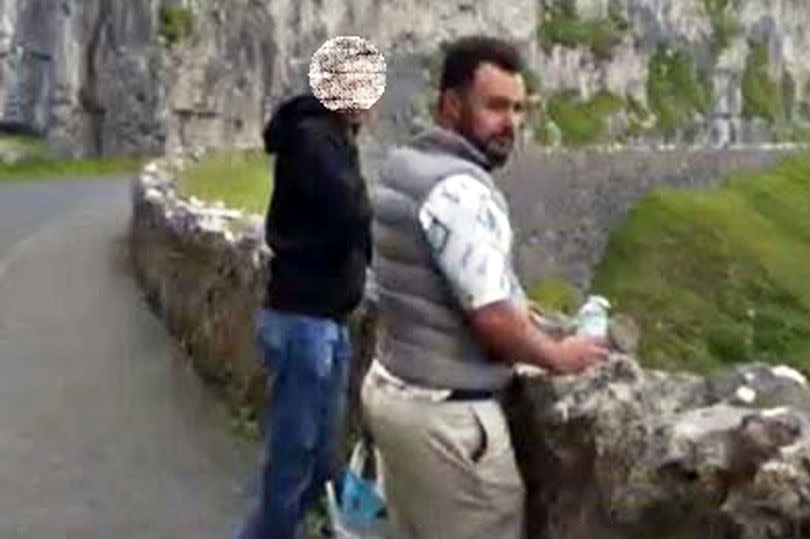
[236,310,351,539]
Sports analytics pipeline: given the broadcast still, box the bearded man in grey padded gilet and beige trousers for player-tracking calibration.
[362,36,608,539]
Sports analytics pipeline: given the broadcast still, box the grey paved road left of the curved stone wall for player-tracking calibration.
[0,176,255,539]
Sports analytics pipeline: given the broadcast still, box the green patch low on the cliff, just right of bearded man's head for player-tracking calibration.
[538,92,625,146]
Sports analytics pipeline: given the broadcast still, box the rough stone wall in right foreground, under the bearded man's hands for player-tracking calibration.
[509,356,810,539]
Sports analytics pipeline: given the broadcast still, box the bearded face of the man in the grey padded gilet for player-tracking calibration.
[454,62,526,167]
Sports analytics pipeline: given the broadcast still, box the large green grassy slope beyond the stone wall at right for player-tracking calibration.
[592,157,810,373]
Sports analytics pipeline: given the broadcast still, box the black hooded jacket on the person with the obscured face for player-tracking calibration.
[264,94,371,321]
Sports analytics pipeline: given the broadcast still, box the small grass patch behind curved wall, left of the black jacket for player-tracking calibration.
[178,151,272,214]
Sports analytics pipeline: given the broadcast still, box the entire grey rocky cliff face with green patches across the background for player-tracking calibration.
[0,0,810,154]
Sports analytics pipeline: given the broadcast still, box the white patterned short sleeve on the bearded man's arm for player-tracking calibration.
[419,174,525,309]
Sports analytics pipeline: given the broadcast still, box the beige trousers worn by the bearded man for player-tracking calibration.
[362,371,525,539]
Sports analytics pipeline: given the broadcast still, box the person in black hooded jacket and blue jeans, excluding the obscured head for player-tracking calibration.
[237,94,371,539]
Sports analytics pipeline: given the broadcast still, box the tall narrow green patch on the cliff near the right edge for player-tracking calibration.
[742,43,785,122]
